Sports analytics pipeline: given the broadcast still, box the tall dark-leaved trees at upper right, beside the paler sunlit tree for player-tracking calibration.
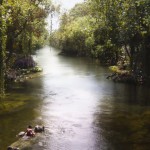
[88,0,150,71]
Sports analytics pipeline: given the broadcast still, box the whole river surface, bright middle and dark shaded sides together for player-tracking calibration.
[0,47,150,150]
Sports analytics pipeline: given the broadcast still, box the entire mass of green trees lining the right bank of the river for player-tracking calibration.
[50,0,150,84]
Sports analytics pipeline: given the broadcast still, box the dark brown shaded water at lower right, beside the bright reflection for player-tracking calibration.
[94,84,150,150]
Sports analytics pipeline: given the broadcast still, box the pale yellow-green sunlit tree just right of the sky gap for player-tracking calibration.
[50,4,94,56]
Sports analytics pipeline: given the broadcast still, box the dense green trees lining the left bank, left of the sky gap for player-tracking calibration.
[0,0,55,94]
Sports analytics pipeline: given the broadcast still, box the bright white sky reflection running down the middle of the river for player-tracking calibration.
[31,48,109,150]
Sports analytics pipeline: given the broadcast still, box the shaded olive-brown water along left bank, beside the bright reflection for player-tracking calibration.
[0,78,42,150]
